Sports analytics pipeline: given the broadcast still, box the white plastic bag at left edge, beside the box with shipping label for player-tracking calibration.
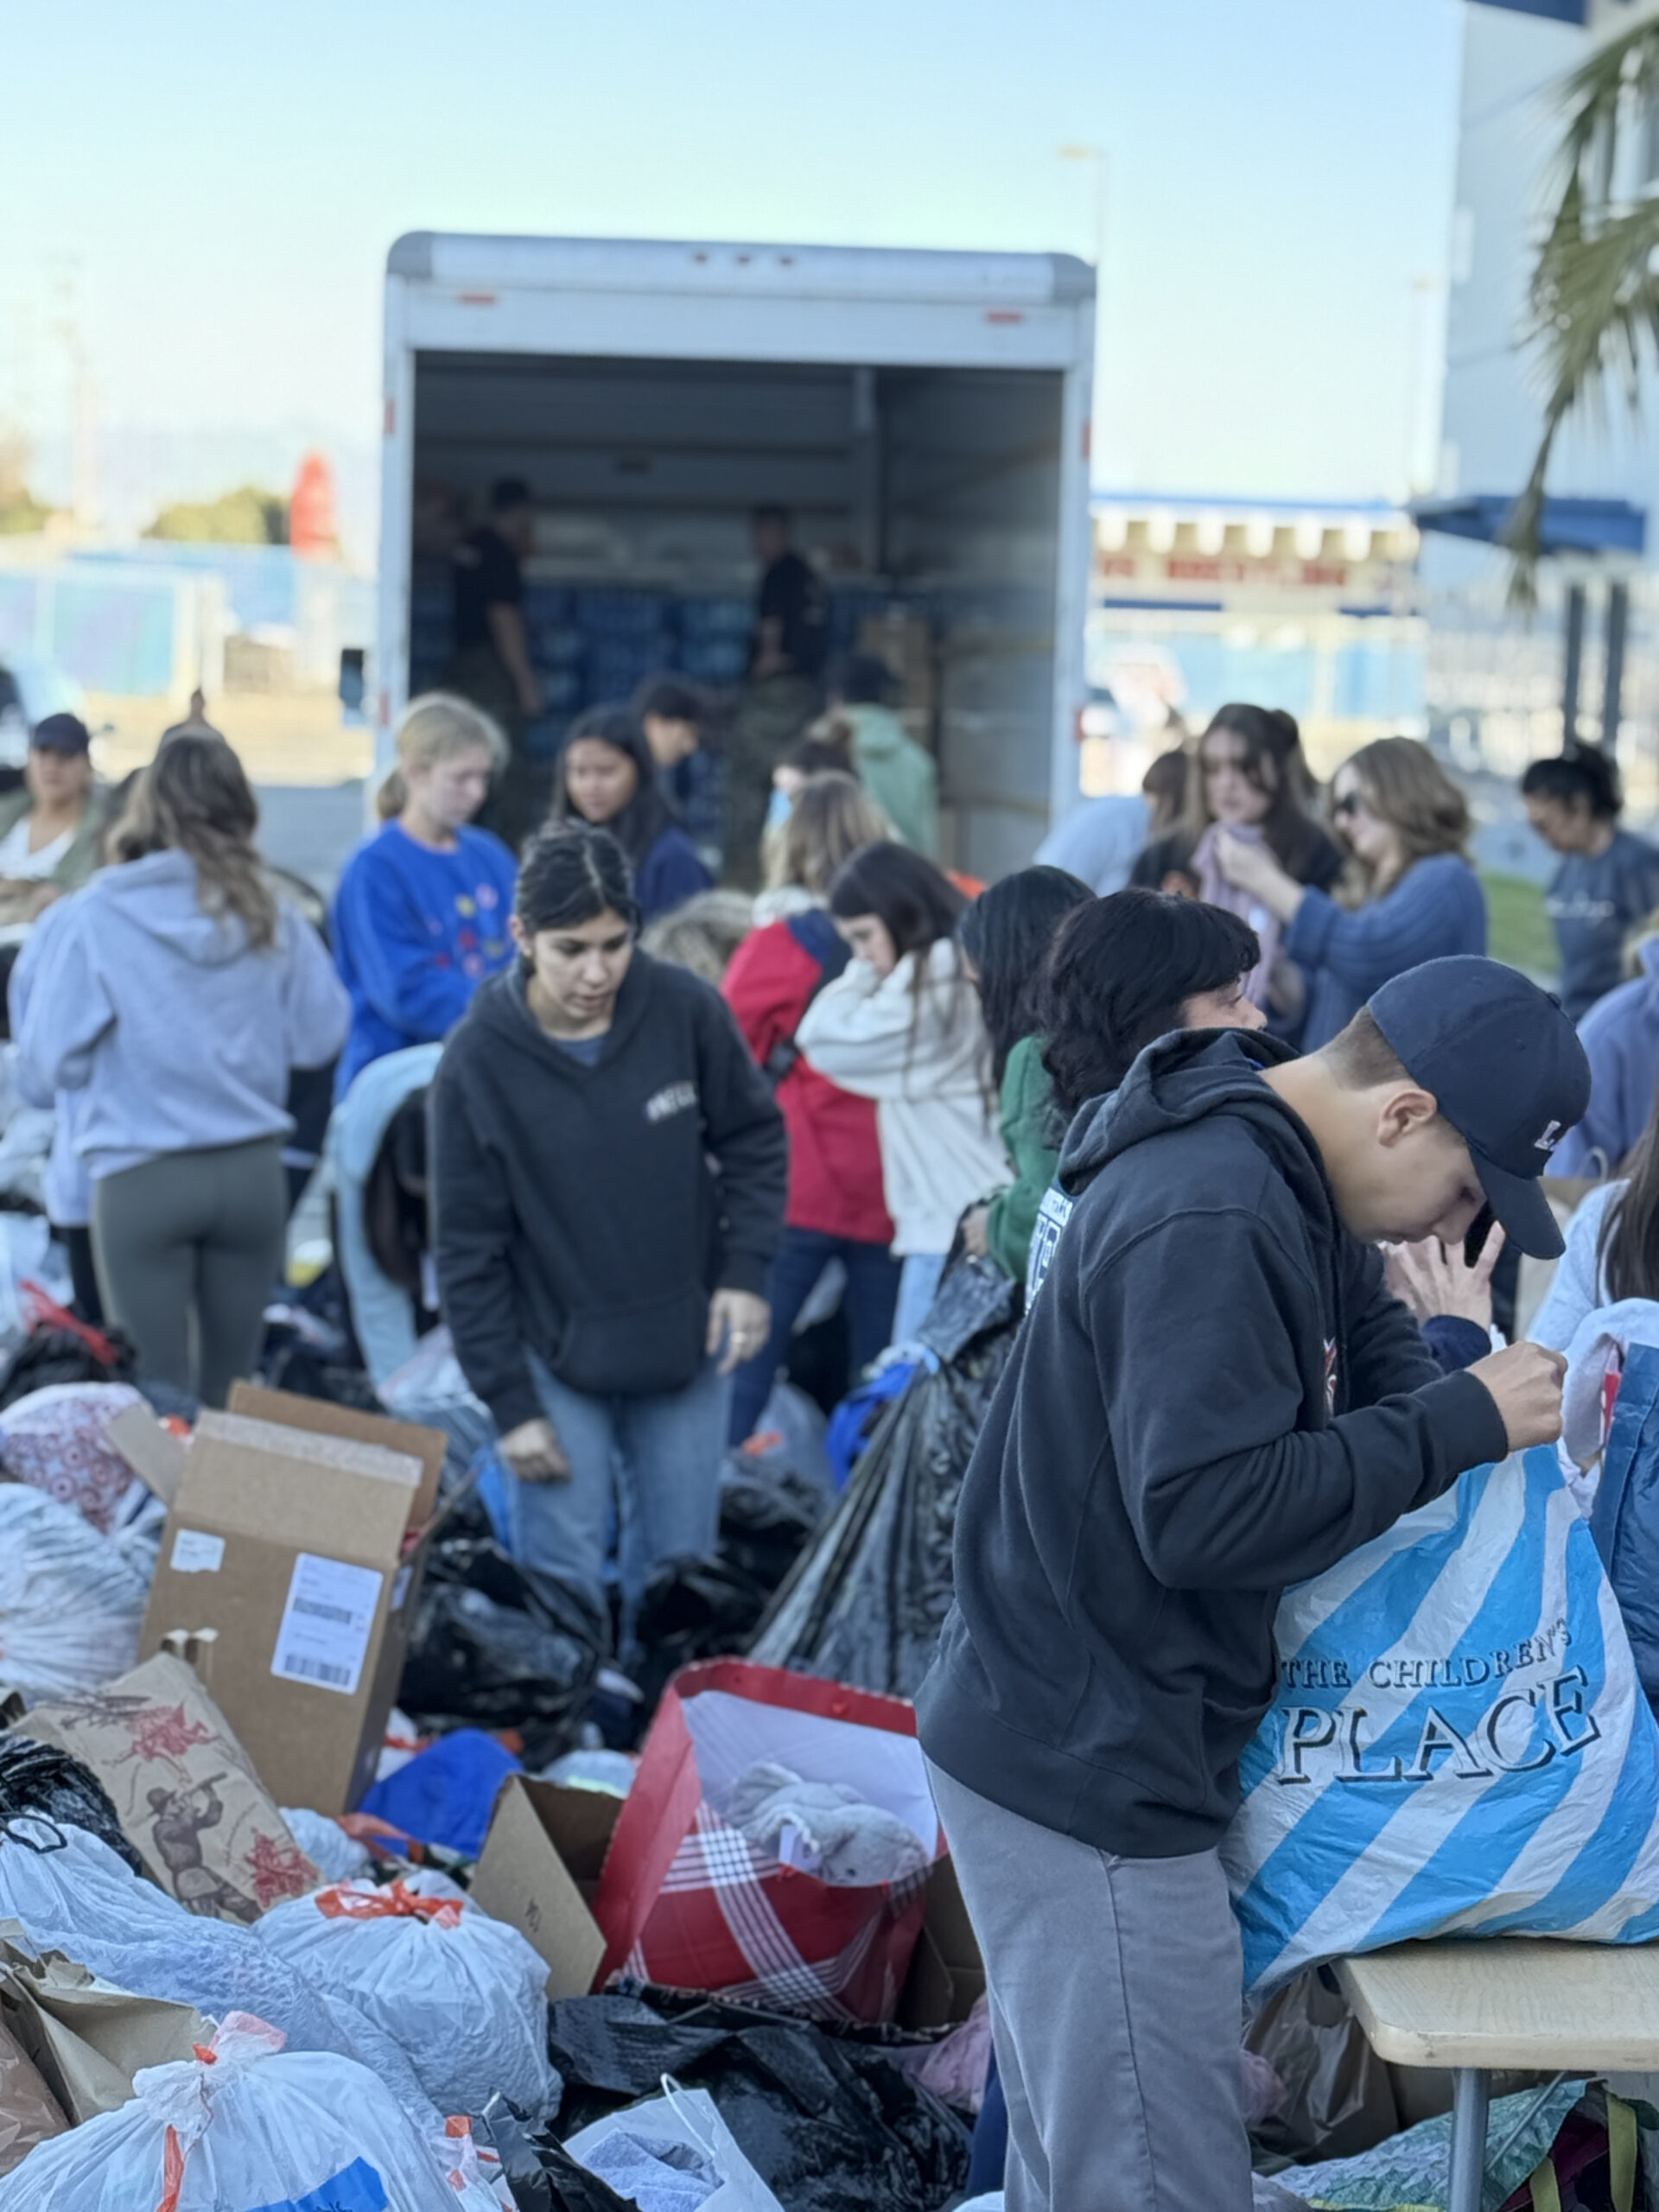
[0,1482,150,1697]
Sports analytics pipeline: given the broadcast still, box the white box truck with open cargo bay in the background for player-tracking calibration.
[374,232,1095,878]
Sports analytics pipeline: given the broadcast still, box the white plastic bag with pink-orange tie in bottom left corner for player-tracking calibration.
[0,2013,495,2212]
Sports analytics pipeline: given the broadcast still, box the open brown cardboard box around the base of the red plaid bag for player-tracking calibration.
[471,1774,984,2029]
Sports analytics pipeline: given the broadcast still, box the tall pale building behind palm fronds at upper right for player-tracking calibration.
[1418,0,1659,812]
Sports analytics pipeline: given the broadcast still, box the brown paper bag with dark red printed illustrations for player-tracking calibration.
[17,1646,323,1927]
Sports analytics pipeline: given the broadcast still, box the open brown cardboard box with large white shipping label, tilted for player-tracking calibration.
[139,1382,445,1814]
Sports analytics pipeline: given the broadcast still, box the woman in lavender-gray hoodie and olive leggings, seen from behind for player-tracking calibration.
[17,734,349,1405]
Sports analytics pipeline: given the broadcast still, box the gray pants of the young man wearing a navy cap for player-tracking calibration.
[929,1765,1252,2212]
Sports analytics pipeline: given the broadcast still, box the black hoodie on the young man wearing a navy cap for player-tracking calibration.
[916,1031,1506,1858]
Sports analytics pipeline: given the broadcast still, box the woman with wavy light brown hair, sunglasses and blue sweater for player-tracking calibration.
[1219,736,1486,1053]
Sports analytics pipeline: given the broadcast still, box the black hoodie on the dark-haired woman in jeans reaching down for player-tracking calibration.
[431,951,787,1433]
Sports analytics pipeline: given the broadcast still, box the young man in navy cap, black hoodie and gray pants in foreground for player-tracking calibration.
[916,956,1588,2212]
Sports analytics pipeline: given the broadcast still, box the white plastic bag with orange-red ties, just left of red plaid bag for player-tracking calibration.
[254,1883,560,2119]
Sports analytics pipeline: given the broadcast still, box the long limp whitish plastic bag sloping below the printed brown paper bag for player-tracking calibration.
[0,1814,434,2121]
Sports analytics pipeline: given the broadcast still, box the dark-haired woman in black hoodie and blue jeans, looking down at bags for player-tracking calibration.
[431,825,785,1619]
